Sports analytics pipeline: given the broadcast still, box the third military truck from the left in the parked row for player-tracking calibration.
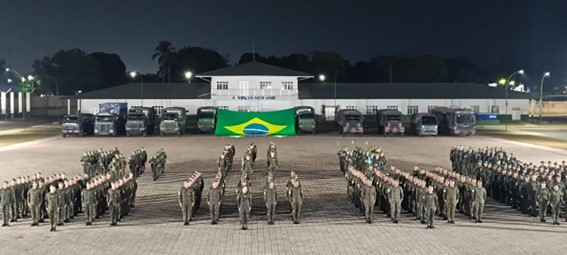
[126,107,156,136]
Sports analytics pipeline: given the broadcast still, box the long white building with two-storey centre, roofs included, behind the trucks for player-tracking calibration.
[74,62,532,120]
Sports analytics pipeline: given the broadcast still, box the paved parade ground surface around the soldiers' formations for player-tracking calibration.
[0,134,567,254]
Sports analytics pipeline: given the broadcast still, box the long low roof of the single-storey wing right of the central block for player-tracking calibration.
[299,82,537,99]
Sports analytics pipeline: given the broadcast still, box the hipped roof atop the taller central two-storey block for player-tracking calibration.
[196,62,313,77]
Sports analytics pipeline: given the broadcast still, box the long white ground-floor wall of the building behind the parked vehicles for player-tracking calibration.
[81,98,530,120]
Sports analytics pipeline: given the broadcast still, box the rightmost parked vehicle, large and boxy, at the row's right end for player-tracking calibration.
[431,107,476,136]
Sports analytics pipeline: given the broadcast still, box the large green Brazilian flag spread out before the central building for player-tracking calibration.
[215,108,295,136]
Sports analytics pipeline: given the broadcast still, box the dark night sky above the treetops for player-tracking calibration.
[0,0,567,85]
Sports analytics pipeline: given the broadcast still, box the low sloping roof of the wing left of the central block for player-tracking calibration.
[70,82,211,99]
